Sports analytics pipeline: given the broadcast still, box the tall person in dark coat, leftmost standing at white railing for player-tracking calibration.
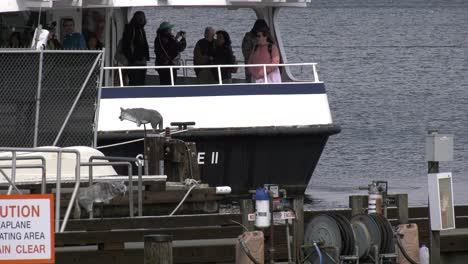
[122,11,149,85]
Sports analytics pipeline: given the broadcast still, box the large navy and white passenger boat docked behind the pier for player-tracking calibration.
[0,0,340,192]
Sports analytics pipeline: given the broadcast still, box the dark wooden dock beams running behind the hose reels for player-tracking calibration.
[55,203,468,264]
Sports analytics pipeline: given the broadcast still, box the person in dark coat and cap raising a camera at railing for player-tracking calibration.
[154,21,187,85]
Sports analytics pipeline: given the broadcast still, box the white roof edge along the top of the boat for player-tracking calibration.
[0,0,310,13]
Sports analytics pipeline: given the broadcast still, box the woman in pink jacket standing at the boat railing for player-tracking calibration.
[248,28,281,83]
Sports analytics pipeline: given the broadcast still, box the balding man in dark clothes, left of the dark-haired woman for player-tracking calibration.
[193,27,215,84]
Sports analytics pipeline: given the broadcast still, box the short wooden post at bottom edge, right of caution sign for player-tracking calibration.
[144,235,172,264]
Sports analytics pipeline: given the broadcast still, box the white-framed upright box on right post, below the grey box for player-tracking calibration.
[427,172,455,231]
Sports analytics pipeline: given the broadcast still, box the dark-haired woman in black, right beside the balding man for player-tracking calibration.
[213,30,237,83]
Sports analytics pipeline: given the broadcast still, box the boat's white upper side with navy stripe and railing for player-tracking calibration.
[98,63,333,131]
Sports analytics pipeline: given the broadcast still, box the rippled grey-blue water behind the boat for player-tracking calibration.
[145,0,468,208]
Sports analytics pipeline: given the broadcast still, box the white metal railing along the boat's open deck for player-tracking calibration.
[103,62,320,87]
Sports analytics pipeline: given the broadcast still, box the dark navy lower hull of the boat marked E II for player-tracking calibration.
[99,125,340,193]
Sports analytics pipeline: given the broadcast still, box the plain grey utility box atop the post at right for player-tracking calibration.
[426,133,453,161]
